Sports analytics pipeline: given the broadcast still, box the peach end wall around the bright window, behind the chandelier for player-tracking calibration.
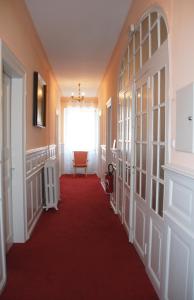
[60,97,98,144]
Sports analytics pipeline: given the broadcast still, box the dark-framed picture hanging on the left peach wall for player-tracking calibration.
[33,72,46,128]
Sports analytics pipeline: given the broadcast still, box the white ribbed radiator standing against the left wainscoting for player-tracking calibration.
[43,158,59,210]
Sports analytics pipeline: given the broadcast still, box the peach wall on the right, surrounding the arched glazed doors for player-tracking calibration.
[98,0,194,169]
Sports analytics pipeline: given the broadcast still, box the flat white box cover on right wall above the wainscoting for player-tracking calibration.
[176,83,194,153]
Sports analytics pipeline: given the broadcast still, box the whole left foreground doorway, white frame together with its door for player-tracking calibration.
[0,40,27,292]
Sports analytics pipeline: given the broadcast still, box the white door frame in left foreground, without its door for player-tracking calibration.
[0,40,28,242]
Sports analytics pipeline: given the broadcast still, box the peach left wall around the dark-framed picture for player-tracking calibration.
[0,0,58,149]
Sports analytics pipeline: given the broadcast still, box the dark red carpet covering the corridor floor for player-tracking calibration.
[0,175,158,300]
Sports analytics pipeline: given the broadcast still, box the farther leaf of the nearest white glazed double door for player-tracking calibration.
[134,79,149,262]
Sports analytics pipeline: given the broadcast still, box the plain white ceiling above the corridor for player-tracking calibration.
[25,0,132,97]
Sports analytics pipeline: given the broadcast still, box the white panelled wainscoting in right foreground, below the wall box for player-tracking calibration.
[163,165,194,300]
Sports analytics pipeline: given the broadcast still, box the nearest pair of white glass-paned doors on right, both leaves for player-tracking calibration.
[134,60,167,290]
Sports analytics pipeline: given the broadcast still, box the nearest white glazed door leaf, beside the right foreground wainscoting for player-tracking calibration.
[147,65,167,292]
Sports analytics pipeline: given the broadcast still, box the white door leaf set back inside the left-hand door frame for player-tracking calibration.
[2,73,13,251]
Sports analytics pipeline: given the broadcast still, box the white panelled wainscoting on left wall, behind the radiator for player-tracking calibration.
[26,145,56,238]
